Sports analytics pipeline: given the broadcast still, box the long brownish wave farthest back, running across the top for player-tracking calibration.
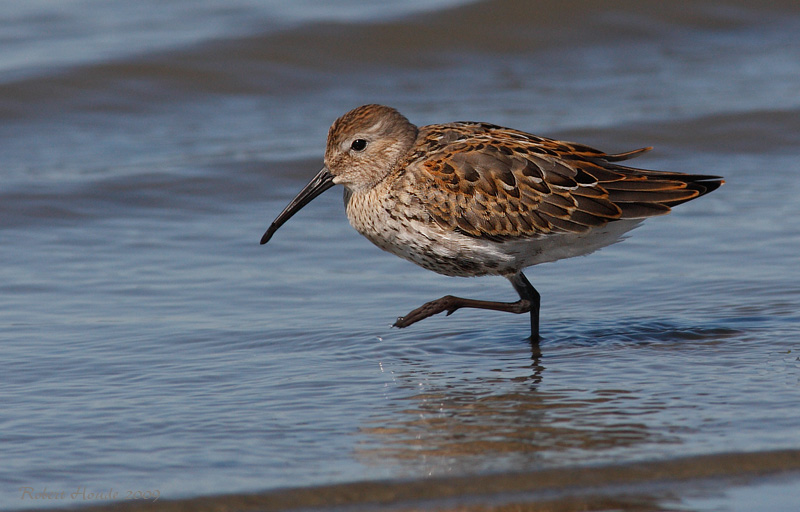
[0,0,800,119]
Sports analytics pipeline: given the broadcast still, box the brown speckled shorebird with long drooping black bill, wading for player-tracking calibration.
[261,105,724,341]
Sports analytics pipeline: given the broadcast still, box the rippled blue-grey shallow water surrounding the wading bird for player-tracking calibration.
[0,0,800,510]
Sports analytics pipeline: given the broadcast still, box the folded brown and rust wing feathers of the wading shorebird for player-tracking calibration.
[414,123,723,241]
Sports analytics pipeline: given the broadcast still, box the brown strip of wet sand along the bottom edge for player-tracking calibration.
[18,450,800,512]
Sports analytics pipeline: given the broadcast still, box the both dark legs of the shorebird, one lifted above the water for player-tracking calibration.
[394,272,539,341]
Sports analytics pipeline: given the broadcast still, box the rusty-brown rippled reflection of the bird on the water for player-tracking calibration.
[357,338,675,475]
